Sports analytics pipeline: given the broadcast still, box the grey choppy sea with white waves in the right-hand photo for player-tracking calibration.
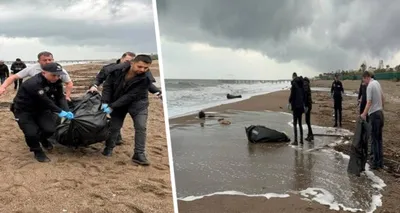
[165,79,290,118]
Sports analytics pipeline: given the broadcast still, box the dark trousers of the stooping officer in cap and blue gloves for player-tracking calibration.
[14,110,57,152]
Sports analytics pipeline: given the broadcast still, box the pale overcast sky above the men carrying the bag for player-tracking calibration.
[0,0,157,60]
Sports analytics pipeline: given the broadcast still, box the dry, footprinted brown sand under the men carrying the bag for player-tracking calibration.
[0,60,173,213]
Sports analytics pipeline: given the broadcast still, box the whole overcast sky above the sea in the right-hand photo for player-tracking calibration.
[157,0,400,79]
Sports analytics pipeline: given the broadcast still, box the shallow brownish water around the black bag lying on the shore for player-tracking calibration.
[171,112,379,210]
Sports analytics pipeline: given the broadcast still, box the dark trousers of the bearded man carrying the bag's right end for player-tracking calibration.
[106,108,148,153]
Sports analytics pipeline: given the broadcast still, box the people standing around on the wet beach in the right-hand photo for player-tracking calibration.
[288,69,385,169]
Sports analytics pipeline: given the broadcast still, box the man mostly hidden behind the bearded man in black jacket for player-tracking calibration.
[89,52,162,146]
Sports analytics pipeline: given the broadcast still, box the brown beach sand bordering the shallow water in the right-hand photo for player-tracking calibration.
[170,81,400,213]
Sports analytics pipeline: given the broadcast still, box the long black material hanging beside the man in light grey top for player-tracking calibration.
[347,118,371,176]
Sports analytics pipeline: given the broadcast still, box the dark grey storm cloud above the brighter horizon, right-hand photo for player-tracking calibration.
[157,0,400,71]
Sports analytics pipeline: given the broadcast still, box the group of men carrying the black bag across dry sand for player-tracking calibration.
[0,51,161,165]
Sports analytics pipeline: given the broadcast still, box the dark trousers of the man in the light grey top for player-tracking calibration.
[369,110,384,168]
